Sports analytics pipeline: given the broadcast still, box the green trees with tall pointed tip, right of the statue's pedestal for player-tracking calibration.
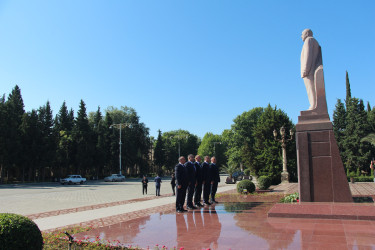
[333,72,375,176]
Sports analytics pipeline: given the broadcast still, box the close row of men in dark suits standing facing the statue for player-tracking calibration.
[175,154,220,213]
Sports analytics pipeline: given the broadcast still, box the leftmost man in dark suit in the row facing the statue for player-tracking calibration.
[174,156,188,213]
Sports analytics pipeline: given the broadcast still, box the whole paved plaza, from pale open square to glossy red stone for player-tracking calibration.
[0,180,375,249]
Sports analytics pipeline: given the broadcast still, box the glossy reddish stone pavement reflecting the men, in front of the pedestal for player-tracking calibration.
[76,194,375,249]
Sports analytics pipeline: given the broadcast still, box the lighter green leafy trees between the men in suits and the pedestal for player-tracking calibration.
[154,105,297,183]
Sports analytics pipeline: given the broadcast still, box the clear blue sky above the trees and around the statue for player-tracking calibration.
[0,0,375,137]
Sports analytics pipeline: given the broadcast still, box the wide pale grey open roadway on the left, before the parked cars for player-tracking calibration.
[0,176,226,215]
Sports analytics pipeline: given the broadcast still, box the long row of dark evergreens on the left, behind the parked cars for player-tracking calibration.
[0,86,152,182]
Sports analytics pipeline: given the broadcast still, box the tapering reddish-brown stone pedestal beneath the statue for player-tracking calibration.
[296,112,353,202]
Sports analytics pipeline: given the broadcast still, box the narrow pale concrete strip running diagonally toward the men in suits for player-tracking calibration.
[30,185,236,231]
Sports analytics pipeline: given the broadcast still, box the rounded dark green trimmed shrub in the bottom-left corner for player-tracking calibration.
[0,213,43,250]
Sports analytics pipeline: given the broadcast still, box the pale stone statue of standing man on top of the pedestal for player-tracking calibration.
[301,29,325,110]
